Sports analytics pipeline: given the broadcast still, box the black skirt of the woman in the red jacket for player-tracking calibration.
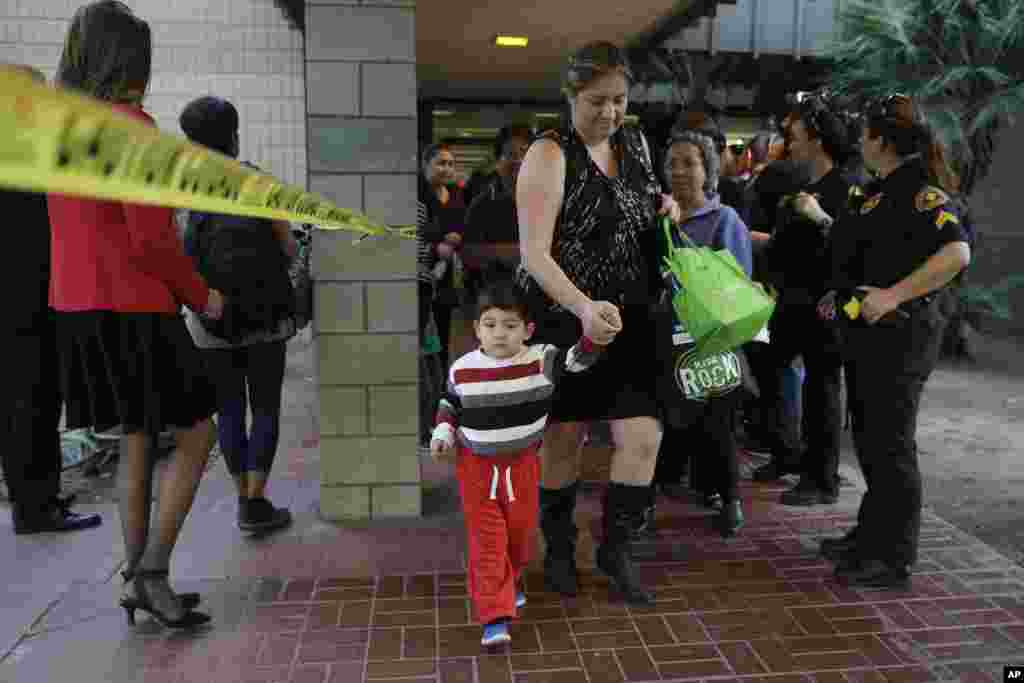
[57,311,217,434]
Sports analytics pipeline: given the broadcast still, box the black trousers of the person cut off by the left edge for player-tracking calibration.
[0,312,61,507]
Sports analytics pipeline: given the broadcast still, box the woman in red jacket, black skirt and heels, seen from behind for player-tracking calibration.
[49,0,224,628]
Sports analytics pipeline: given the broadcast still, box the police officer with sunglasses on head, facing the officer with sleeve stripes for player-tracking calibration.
[755,91,859,506]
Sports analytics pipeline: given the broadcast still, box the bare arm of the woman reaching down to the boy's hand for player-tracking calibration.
[516,140,590,316]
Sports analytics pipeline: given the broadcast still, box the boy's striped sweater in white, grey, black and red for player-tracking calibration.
[432,337,601,456]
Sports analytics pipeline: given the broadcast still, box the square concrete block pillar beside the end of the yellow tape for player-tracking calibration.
[305,0,422,520]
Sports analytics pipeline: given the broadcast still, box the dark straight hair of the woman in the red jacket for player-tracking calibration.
[55,0,153,102]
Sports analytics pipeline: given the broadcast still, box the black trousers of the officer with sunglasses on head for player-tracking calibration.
[762,305,843,493]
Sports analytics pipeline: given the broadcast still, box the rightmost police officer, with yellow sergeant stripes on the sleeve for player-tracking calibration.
[818,95,971,588]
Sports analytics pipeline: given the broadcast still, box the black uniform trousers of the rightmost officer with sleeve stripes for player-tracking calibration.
[844,315,942,566]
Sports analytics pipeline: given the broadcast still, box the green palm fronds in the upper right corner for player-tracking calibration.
[827,0,1024,194]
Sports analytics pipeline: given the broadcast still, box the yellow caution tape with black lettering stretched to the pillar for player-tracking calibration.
[0,67,416,240]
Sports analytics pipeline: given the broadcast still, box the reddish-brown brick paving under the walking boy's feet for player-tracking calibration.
[12,471,1024,683]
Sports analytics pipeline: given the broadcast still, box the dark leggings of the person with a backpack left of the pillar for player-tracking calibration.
[204,341,287,476]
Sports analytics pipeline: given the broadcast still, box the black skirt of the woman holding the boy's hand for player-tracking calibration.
[531,304,660,422]
